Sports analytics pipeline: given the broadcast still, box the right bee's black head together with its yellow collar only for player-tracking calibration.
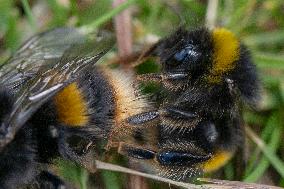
[155,28,244,83]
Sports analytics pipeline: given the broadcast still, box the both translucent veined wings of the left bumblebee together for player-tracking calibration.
[0,29,115,149]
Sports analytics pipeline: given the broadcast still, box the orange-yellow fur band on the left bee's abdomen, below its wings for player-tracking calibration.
[54,83,89,126]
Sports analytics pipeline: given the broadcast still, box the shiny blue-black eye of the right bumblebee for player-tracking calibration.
[174,45,200,63]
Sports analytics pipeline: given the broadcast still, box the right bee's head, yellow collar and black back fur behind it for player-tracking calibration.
[146,28,259,103]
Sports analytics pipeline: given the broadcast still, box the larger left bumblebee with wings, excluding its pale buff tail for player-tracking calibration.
[0,28,118,189]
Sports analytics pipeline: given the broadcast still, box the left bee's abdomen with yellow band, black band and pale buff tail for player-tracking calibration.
[50,66,150,145]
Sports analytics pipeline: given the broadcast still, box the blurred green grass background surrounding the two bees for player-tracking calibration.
[0,0,284,189]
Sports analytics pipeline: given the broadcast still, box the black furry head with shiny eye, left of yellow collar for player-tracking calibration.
[157,28,213,77]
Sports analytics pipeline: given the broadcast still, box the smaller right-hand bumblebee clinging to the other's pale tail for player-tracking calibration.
[117,28,259,180]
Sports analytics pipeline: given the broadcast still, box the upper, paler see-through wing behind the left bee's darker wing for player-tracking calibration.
[0,28,107,92]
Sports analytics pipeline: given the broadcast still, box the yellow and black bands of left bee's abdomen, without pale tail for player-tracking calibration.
[52,66,115,131]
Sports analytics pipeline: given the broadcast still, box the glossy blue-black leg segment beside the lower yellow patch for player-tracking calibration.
[157,152,211,166]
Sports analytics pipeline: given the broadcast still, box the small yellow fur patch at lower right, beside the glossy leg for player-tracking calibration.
[202,151,234,173]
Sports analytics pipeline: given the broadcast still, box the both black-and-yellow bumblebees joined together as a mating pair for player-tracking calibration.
[0,25,259,188]
